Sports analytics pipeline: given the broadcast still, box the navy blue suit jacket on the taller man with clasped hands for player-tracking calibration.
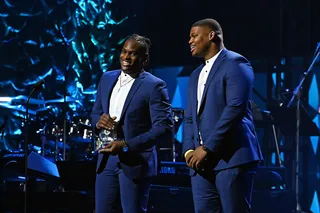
[183,48,263,170]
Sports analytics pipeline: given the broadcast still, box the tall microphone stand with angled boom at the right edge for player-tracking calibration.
[287,44,320,213]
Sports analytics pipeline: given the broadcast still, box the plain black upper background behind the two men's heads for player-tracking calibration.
[109,0,320,67]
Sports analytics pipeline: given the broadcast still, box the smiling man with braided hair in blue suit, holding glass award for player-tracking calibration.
[91,34,173,213]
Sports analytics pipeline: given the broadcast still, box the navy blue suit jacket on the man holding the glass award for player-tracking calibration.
[91,70,173,179]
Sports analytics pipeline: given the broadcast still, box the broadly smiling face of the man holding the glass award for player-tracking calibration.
[120,39,146,74]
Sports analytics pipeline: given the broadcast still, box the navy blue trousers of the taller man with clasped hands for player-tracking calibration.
[191,166,255,213]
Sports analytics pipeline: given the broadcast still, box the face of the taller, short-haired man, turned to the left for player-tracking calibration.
[189,26,214,59]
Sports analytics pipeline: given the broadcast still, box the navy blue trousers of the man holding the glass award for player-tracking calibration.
[95,156,150,213]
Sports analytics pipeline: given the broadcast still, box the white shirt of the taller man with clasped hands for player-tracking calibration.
[197,49,222,112]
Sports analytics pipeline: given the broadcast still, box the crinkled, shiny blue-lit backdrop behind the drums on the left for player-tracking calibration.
[0,0,130,150]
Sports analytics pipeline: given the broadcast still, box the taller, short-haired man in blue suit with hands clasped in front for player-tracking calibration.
[183,19,263,213]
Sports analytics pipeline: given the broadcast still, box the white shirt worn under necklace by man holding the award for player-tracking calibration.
[109,71,135,121]
